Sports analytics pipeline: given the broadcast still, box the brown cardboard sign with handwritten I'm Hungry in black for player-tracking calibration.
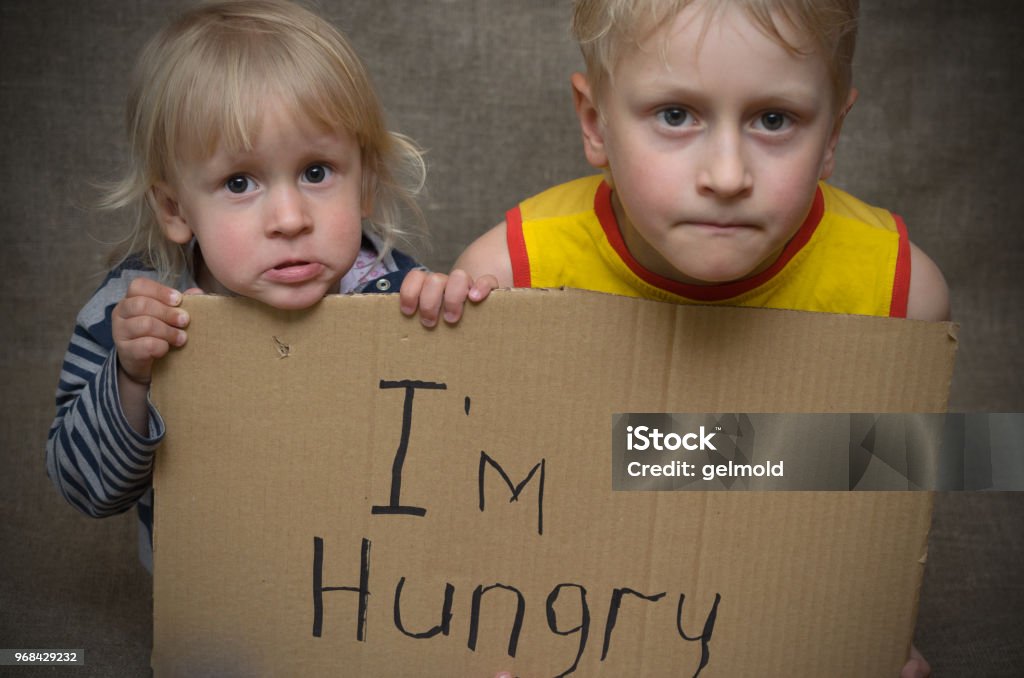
[153,290,956,677]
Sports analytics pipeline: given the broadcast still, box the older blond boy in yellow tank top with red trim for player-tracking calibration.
[442,0,949,320]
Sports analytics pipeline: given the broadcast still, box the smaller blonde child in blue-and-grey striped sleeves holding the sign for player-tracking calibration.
[46,0,489,568]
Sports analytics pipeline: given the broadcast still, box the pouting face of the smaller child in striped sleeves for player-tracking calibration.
[155,100,364,308]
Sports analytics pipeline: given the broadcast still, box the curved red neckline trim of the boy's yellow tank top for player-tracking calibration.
[594,181,825,301]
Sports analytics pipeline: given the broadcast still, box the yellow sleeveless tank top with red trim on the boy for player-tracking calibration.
[506,176,910,317]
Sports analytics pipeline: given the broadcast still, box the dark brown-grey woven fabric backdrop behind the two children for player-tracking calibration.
[0,0,1024,676]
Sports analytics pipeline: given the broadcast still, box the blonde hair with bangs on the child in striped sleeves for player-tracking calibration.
[101,0,425,281]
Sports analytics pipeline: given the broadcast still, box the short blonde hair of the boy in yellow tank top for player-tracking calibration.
[572,0,859,115]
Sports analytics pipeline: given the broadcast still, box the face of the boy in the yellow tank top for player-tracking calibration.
[573,2,853,284]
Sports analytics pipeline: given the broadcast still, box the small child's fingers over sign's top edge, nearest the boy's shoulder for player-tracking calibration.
[398,268,498,328]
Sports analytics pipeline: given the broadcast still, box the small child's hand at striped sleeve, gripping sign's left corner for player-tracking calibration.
[112,278,201,384]
